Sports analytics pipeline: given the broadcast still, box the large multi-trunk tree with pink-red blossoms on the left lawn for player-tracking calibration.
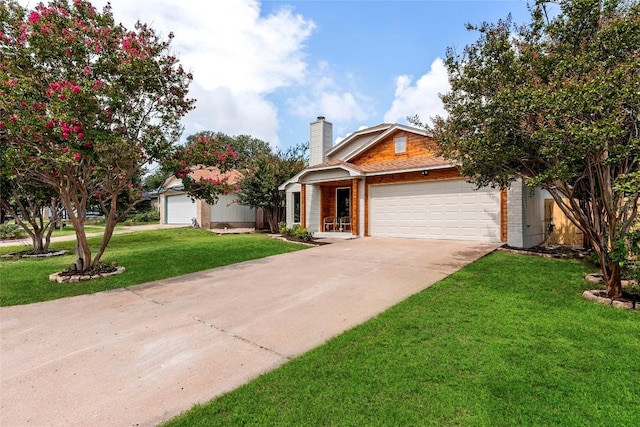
[0,0,194,272]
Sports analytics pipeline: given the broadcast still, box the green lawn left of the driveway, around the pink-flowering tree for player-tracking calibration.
[0,228,306,306]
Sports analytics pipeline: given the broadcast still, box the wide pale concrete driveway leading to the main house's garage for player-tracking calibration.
[0,238,496,426]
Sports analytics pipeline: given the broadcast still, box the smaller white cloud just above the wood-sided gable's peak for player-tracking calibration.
[384,58,450,127]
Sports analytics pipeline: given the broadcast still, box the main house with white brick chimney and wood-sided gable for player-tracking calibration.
[280,117,548,247]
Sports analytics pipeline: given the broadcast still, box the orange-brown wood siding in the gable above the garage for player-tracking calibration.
[351,131,436,165]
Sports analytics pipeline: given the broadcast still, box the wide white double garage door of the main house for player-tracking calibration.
[369,180,500,242]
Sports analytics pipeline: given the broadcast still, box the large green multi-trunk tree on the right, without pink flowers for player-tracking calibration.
[424,0,640,297]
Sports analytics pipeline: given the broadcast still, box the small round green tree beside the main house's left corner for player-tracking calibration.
[238,143,309,233]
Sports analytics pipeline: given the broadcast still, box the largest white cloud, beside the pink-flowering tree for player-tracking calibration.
[22,0,315,145]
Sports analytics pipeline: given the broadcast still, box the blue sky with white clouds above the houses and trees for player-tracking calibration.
[21,0,529,148]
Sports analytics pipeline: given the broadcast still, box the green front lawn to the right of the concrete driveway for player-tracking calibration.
[167,252,640,426]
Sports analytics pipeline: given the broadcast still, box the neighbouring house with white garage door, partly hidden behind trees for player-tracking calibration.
[159,167,263,229]
